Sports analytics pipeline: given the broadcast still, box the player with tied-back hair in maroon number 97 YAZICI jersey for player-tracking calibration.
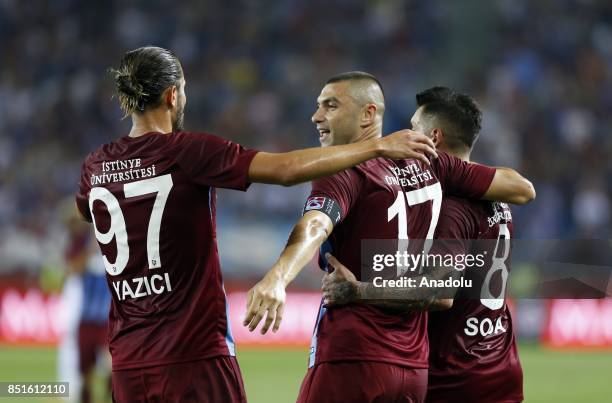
[76,46,435,402]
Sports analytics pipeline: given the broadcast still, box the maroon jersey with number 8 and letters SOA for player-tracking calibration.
[427,197,523,403]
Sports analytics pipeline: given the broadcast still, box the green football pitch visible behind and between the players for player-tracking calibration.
[0,344,612,403]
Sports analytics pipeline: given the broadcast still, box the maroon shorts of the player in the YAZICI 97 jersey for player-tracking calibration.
[112,357,246,403]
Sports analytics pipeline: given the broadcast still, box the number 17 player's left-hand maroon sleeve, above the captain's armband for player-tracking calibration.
[305,169,363,224]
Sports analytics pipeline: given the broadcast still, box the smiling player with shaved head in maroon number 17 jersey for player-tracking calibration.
[244,72,534,403]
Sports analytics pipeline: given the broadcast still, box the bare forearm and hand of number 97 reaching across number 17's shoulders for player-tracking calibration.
[249,130,437,186]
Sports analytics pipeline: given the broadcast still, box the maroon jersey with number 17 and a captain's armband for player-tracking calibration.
[305,153,495,368]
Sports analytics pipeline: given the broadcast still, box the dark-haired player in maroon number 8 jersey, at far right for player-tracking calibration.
[412,87,523,403]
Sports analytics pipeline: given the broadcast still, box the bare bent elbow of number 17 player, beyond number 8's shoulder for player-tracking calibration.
[482,168,536,204]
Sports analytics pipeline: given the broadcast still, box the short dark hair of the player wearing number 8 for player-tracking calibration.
[416,87,482,149]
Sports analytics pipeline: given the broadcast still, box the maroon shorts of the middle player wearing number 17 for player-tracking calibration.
[297,361,427,403]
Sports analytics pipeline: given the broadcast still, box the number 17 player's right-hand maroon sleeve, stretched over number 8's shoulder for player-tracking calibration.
[432,152,495,199]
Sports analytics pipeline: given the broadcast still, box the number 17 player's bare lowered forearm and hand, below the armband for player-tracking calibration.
[243,210,333,334]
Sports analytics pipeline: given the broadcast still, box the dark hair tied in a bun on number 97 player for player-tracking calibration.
[109,46,183,116]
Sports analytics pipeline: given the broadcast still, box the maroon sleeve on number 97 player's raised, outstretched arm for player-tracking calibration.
[173,132,258,190]
